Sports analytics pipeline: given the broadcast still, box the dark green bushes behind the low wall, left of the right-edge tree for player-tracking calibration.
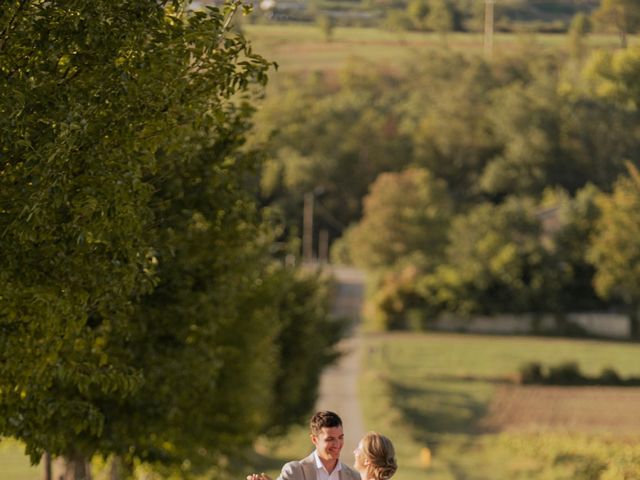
[417,186,601,318]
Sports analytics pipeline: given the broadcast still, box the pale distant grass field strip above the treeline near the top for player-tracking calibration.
[243,24,639,73]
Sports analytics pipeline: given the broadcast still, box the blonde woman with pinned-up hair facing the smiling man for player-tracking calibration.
[353,432,398,480]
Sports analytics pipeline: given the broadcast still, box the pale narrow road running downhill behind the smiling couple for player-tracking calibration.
[316,267,366,465]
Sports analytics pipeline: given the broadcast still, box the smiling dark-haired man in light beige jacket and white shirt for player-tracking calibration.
[247,411,360,480]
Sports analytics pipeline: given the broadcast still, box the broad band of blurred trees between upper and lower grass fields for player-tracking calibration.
[252,40,640,336]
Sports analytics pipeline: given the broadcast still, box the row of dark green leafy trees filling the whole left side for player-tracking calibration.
[0,0,338,480]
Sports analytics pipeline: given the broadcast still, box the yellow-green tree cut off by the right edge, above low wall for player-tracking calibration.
[588,164,640,339]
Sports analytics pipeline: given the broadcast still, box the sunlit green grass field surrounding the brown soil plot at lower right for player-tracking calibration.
[361,334,640,480]
